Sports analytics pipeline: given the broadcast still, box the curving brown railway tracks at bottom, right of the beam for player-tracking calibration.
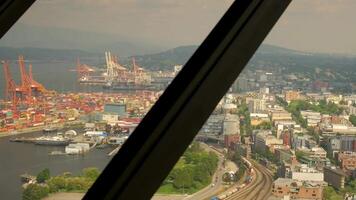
[224,160,273,200]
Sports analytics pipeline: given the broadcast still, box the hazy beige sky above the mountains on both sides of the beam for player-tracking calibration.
[10,0,356,54]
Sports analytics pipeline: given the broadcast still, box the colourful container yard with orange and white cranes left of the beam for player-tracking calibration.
[0,52,160,136]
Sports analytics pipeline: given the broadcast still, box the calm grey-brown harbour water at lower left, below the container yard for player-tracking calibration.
[0,133,111,200]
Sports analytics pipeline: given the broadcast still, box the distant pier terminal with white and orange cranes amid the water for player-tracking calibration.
[75,52,182,91]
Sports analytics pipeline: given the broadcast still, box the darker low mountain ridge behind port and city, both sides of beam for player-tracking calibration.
[0,40,356,77]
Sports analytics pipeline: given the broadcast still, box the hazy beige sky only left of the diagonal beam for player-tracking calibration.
[21,0,233,45]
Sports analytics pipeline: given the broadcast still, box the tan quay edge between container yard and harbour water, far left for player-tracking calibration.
[0,120,83,138]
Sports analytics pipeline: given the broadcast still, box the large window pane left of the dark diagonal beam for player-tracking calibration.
[0,0,232,199]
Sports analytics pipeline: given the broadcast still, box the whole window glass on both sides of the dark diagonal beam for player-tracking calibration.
[0,0,356,200]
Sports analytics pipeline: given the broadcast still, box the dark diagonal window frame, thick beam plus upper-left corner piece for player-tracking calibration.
[0,0,291,199]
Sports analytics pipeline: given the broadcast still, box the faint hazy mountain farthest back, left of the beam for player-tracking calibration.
[0,23,168,56]
